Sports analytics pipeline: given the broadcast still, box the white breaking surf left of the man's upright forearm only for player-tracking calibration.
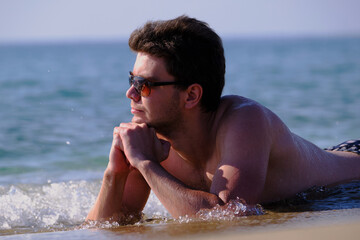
[0,181,99,232]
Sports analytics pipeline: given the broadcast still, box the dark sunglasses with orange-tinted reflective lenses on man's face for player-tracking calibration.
[129,72,183,97]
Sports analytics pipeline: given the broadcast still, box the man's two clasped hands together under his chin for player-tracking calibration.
[110,123,170,170]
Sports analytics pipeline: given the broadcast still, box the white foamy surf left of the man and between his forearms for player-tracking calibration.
[0,180,170,236]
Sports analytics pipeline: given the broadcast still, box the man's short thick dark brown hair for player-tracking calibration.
[129,16,225,111]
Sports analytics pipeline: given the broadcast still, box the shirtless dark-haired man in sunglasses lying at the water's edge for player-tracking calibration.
[87,16,360,220]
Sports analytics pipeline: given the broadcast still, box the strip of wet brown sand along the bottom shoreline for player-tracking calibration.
[3,208,360,240]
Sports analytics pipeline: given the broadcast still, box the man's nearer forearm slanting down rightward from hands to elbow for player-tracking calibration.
[138,161,223,218]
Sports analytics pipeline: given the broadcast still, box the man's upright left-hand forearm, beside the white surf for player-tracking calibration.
[86,170,129,221]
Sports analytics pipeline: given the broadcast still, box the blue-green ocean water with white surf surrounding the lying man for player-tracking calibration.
[0,38,360,239]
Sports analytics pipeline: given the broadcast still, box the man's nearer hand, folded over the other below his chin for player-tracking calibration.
[119,123,170,168]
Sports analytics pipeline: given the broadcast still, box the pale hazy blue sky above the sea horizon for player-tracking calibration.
[0,0,360,43]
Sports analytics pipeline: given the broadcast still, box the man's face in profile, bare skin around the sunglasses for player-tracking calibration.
[126,52,181,135]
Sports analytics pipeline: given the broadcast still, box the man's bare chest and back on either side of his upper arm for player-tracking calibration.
[162,96,360,202]
